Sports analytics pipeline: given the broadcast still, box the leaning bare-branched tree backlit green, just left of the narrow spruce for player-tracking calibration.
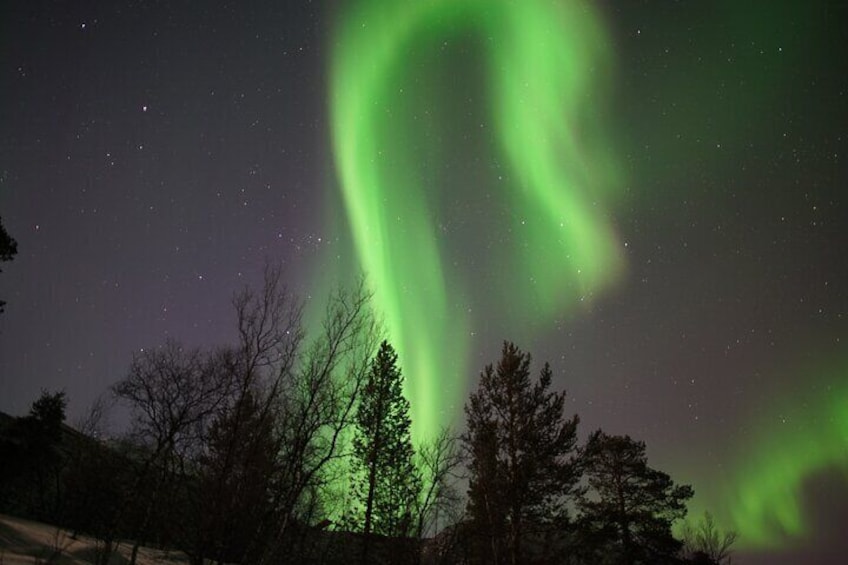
[255,281,379,565]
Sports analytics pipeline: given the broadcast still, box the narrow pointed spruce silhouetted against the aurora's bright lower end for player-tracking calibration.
[353,341,421,562]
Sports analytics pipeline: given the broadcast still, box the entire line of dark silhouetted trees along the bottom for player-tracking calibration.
[0,267,735,565]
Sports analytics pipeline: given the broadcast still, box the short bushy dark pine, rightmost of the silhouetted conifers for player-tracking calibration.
[578,430,693,565]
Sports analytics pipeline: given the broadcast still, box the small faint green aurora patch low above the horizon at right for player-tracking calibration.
[690,362,848,550]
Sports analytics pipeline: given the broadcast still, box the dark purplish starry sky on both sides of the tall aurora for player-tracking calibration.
[0,0,848,563]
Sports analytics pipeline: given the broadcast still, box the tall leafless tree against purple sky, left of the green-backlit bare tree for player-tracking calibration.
[188,264,303,562]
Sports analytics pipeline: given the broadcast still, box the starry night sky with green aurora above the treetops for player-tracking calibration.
[0,0,848,563]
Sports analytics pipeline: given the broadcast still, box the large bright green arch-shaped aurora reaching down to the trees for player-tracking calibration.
[330,0,622,437]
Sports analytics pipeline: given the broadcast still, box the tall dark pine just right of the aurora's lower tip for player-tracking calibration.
[463,343,579,565]
